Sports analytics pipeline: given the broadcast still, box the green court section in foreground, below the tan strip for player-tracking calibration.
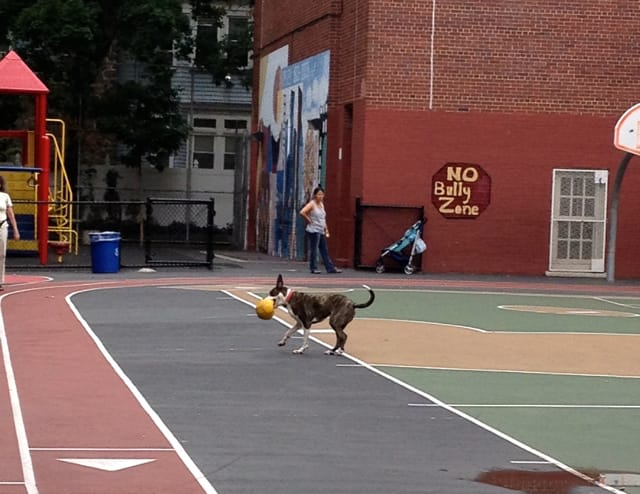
[380,367,640,472]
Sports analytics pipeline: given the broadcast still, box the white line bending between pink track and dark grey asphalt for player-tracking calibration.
[65,287,218,494]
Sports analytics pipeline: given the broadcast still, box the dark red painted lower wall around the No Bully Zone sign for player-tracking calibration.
[362,110,640,278]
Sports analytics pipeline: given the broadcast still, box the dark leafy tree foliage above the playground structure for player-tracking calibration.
[0,0,255,168]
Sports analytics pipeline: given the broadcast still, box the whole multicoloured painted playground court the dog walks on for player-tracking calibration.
[0,265,640,494]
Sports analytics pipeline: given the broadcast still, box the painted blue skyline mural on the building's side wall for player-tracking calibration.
[257,47,330,259]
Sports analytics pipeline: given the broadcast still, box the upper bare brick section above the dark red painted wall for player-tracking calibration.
[367,0,640,115]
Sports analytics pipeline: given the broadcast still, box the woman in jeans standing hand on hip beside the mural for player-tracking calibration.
[300,187,342,274]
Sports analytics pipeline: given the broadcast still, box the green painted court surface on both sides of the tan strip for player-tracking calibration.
[360,290,640,494]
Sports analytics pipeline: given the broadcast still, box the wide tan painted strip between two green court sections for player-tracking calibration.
[313,317,640,377]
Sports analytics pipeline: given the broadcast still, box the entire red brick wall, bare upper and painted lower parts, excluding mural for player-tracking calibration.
[256,0,640,278]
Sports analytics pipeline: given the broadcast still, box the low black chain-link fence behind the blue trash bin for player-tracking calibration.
[7,198,226,269]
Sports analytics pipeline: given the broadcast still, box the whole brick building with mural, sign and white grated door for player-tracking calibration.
[248,0,640,278]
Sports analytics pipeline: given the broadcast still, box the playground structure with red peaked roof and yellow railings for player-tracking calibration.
[0,51,78,265]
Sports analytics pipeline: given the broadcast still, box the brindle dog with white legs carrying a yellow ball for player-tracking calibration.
[269,274,376,355]
